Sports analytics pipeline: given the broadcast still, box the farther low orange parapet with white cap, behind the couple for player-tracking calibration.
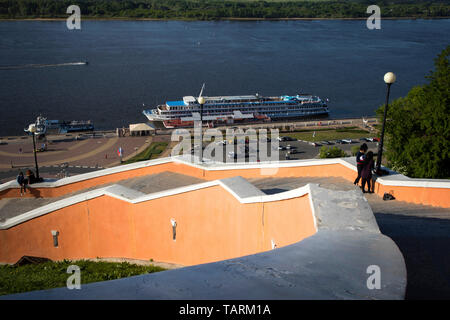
[0,156,450,208]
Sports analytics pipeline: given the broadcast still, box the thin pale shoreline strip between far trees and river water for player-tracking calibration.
[0,17,450,22]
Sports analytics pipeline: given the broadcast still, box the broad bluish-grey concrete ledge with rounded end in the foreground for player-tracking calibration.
[0,231,406,300]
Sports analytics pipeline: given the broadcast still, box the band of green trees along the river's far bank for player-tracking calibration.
[0,0,450,20]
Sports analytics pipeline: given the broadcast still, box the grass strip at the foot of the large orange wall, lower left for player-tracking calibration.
[0,260,166,295]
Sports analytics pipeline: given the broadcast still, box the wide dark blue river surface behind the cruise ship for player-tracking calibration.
[0,20,450,135]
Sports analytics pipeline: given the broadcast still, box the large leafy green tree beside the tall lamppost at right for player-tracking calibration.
[377,46,450,179]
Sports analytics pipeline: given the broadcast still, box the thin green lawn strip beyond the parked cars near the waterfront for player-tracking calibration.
[280,128,373,142]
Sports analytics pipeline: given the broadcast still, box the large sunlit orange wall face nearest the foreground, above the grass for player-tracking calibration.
[0,186,316,265]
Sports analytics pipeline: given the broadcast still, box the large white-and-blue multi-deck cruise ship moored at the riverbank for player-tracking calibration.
[143,90,329,128]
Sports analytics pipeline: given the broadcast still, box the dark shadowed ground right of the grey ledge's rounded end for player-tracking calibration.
[375,213,450,300]
